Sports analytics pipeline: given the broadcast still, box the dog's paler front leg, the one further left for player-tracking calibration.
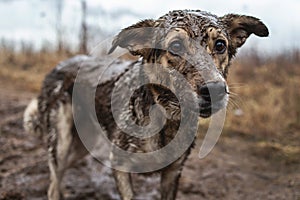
[113,170,133,200]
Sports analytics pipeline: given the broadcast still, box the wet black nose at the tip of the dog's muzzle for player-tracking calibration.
[199,82,227,102]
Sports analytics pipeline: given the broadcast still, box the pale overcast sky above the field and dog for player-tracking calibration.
[0,0,300,51]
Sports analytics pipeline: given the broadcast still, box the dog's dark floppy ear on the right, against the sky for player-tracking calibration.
[220,14,269,49]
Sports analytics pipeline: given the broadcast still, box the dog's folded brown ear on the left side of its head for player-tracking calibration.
[108,19,155,56]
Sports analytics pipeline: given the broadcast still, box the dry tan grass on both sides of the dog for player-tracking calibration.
[0,47,300,169]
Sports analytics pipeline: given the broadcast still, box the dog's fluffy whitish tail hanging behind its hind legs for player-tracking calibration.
[23,98,42,136]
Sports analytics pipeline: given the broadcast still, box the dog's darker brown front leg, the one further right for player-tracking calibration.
[161,152,188,200]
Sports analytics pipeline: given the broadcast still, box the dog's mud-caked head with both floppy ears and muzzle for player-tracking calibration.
[110,10,269,117]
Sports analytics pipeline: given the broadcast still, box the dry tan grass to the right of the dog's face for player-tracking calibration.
[225,50,300,167]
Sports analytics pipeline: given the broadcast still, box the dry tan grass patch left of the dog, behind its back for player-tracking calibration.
[0,49,71,92]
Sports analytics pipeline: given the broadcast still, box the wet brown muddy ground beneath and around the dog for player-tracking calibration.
[0,84,300,200]
